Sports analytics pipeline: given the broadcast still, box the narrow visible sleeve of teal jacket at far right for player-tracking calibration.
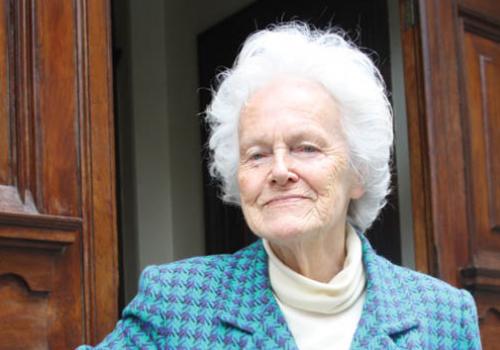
[457,290,482,350]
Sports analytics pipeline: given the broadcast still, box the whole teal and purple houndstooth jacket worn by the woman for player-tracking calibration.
[80,236,481,350]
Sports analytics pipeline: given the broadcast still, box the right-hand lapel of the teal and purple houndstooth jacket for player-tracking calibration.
[351,234,419,349]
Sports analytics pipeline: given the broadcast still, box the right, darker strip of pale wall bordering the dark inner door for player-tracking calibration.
[165,0,258,260]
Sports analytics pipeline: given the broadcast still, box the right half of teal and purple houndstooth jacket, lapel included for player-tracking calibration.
[352,237,481,350]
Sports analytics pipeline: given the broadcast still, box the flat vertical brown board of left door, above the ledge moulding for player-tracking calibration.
[35,0,81,216]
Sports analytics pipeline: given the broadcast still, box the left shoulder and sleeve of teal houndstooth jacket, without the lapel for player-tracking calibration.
[81,245,264,350]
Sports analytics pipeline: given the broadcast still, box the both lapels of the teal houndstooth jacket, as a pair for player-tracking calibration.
[219,234,419,350]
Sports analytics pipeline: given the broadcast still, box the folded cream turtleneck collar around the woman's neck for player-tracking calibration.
[263,225,365,314]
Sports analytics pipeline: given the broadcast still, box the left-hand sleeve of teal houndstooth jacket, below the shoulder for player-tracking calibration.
[78,266,164,350]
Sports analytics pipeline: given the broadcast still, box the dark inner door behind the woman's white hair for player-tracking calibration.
[198,0,401,264]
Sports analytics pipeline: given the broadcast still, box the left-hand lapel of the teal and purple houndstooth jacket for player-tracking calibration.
[219,240,297,349]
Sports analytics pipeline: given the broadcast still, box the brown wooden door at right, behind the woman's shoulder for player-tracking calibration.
[401,0,500,349]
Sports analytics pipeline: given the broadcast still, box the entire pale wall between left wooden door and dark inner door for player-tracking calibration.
[122,0,252,301]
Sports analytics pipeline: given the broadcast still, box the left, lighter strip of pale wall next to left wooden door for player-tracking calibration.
[130,0,174,270]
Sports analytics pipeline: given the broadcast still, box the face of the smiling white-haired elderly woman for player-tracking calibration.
[238,77,363,243]
